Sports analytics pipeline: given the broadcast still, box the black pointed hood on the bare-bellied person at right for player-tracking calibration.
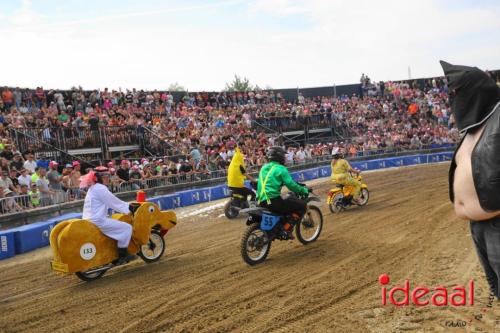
[440,60,500,134]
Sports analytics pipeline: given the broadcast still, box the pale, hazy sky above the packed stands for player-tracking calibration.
[0,0,500,91]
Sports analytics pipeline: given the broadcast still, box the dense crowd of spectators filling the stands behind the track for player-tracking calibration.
[0,69,500,213]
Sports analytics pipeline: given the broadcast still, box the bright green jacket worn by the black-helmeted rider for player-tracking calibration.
[257,162,309,203]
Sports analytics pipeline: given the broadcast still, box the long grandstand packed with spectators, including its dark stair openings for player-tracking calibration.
[0,71,500,213]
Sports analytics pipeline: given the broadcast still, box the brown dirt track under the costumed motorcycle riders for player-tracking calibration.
[0,165,500,332]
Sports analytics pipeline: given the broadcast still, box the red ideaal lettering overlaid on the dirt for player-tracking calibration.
[378,274,474,306]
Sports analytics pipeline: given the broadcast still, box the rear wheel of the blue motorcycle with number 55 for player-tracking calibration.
[241,223,271,266]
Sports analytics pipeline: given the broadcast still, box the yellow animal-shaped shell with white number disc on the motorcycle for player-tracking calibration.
[50,202,177,273]
